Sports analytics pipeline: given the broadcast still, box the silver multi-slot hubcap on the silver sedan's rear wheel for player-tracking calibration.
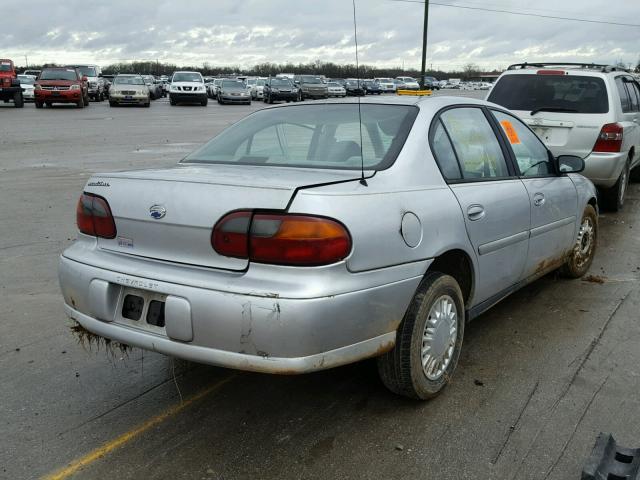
[421,295,458,380]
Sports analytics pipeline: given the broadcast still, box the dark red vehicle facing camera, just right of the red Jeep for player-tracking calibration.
[34,67,89,108]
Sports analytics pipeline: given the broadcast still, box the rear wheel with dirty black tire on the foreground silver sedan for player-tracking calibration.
[378,272,465,400]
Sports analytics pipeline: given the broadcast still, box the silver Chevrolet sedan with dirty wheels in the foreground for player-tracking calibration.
[59,97,598,399]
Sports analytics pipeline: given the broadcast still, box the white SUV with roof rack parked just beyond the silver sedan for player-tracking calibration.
[487,63,640,211]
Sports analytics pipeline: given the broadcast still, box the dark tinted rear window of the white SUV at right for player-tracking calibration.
[487,74,609,113]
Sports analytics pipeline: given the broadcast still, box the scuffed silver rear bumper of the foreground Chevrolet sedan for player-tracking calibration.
[58,251,422,374]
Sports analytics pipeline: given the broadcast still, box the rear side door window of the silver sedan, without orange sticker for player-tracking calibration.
[440,107,509,180]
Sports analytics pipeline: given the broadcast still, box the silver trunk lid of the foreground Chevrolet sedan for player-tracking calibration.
[85,165,360,270]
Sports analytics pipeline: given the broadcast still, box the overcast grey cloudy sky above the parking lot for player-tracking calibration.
[0,0,640,69]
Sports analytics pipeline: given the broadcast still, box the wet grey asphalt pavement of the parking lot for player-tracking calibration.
[0,92,640,480]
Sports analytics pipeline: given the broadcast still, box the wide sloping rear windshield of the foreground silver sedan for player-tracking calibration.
[183,103,418,170]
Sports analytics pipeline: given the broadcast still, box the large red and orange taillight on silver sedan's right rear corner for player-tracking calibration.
[211,211,351,266]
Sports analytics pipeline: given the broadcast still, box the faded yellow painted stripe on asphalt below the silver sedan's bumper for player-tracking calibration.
[42,375,236,480]
